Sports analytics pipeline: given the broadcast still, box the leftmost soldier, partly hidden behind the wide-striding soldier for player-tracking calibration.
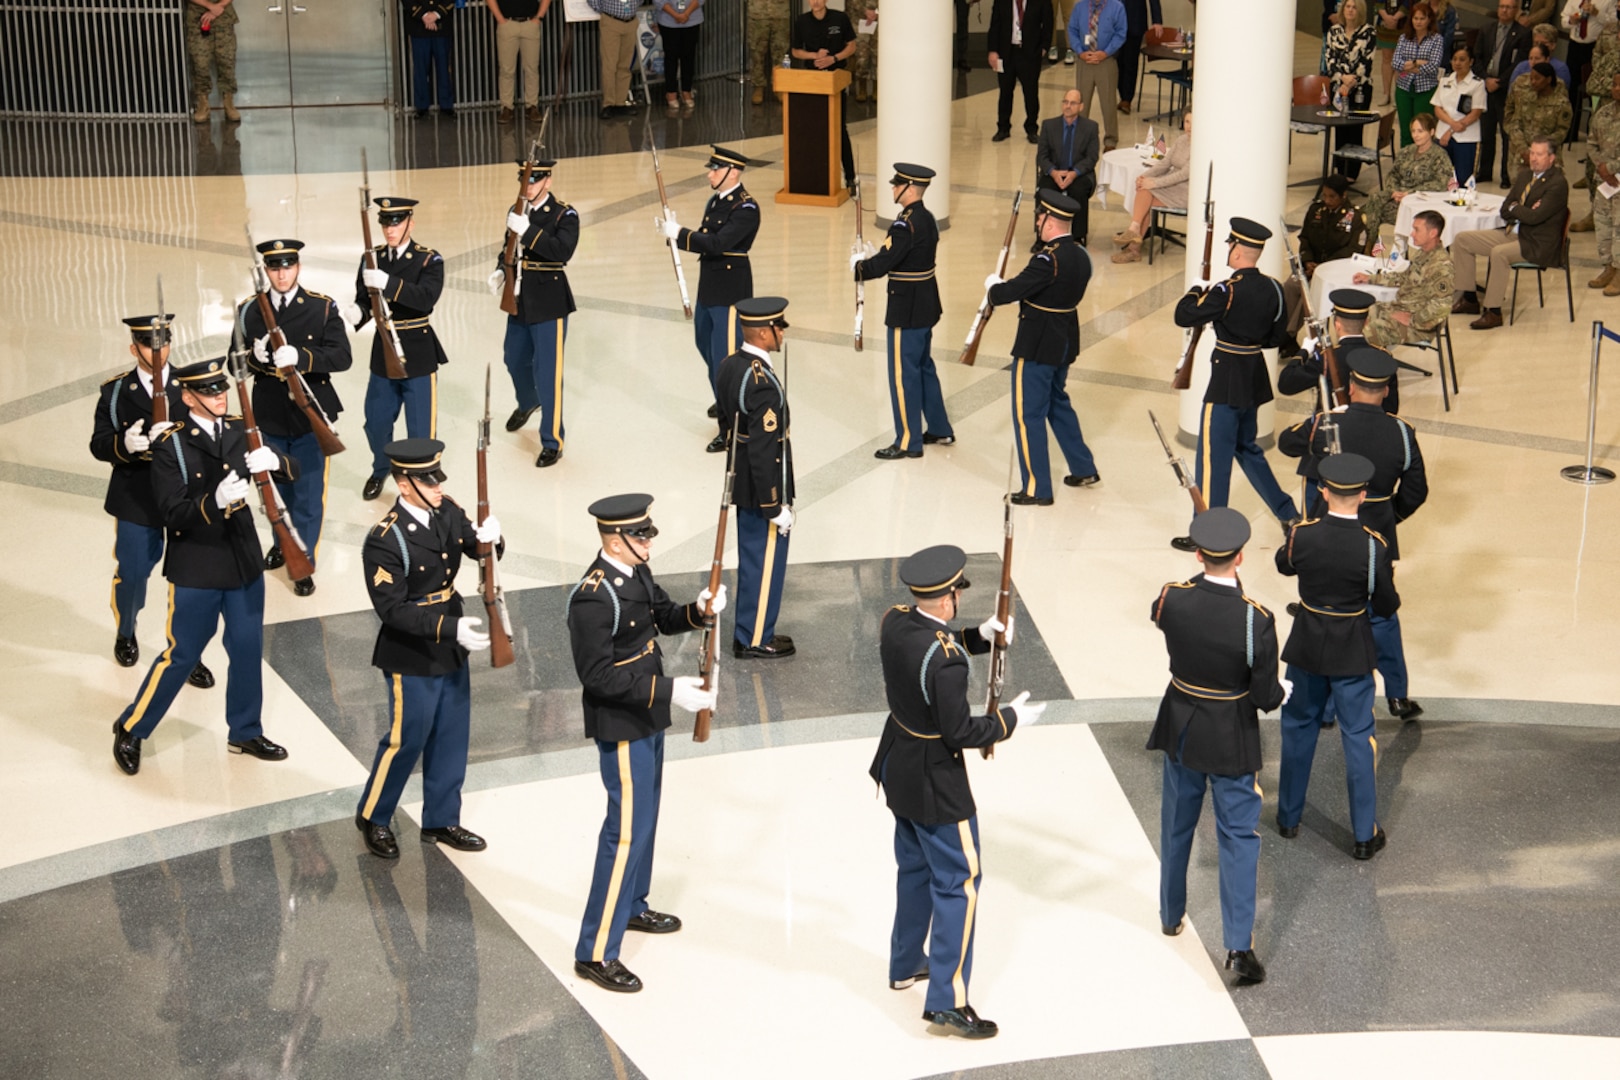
[91,314,214,690]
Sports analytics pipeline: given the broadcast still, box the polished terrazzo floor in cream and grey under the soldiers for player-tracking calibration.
[0,31,1620,1080]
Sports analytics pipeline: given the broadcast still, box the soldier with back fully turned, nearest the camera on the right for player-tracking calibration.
[1147,507,1291,983]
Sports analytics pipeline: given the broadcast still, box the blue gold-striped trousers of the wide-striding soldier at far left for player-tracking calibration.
[118,575,264,743]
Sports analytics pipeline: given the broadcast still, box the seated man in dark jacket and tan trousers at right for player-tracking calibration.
[1452,136,1570,330]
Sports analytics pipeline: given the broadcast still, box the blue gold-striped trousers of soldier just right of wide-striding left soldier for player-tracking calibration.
[358,664,473,829]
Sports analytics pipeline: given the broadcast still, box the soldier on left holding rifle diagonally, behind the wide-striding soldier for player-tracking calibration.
[241,240,355,596]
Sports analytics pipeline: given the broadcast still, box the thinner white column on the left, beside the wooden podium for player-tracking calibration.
[881,0,952,228]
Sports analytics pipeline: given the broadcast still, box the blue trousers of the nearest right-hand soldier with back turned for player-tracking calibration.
[1158,753,1262,949]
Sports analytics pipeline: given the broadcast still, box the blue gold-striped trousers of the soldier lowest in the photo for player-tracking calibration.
[889,814,983,1012]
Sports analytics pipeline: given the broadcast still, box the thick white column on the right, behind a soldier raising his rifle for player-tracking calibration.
[1179,0,1294,439]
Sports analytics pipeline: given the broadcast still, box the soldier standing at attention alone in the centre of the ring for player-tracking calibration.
[719,296,795,659]
